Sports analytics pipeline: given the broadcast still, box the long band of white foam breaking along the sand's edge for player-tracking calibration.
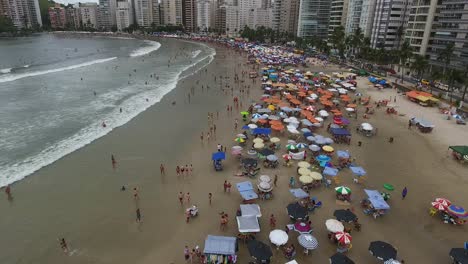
[0,44,216,187]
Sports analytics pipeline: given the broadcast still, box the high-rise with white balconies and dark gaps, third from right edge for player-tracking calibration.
[370,0,413,49]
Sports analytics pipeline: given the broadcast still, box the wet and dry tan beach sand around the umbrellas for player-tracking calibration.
[0,39,468,264]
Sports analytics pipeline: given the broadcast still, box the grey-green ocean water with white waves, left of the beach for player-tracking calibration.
[0,34,215,186]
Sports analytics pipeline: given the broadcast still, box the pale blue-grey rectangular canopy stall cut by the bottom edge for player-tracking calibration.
[203,235,239,264]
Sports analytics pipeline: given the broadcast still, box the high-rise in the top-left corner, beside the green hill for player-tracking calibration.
[0,0,42,29]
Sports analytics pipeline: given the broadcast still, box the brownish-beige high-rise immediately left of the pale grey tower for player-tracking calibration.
[271,0,300,35]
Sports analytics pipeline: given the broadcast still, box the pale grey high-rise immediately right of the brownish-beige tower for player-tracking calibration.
[297,0,331,39]
